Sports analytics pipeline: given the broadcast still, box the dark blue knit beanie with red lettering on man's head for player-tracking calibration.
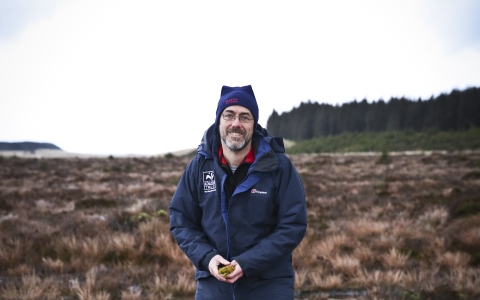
[215,85,258,128]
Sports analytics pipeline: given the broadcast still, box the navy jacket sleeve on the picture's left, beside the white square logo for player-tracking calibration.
[169,159,214,271]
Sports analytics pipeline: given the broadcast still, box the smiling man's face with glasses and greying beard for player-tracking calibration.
[219,105,254,152]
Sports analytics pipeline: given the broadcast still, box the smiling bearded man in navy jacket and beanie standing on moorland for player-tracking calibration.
[169,86,307,300]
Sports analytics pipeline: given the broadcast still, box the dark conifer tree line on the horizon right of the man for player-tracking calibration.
[267,87,480,141]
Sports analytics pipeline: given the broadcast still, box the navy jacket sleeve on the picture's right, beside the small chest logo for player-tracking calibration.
[235,157,307,276]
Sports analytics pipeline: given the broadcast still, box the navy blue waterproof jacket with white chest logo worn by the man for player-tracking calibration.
[169,124,307,289]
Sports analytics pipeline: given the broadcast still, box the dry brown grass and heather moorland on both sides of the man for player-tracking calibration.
[0,154,480,300]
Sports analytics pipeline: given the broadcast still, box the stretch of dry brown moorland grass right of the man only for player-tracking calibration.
[292,155,480,299]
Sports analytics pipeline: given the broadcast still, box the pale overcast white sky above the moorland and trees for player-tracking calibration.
[0,0,480,155]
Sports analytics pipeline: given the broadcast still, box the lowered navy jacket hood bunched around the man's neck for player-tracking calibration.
[197,124,285,158]
